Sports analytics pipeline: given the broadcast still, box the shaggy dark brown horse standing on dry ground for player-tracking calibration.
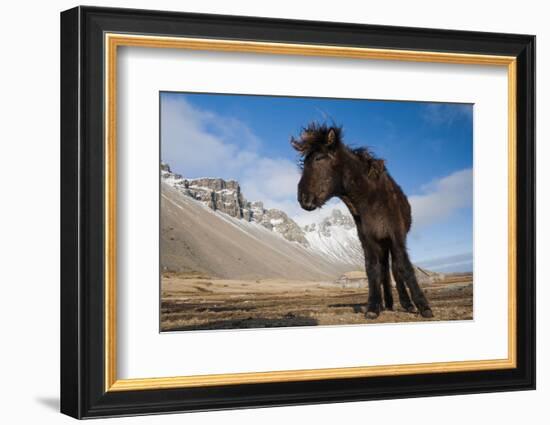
[291,123,433,319]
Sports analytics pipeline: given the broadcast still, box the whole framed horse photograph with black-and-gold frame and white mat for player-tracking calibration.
[61,7,535,418]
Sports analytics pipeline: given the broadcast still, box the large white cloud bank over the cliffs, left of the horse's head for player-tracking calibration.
[161,97,300,213]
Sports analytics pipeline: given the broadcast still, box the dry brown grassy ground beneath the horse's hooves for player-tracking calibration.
[161,273,473,331]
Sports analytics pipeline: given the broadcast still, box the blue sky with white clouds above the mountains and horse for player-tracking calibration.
[161,92,473,271]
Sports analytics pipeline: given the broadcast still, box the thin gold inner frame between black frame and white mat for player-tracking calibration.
[105,33,516,391]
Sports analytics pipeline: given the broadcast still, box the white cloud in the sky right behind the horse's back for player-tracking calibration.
[409,168,473,230]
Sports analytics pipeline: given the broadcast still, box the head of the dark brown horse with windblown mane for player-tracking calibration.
[290,123,342,211]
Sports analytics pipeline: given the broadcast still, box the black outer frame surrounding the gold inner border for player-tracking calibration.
[61,6,535,418]
